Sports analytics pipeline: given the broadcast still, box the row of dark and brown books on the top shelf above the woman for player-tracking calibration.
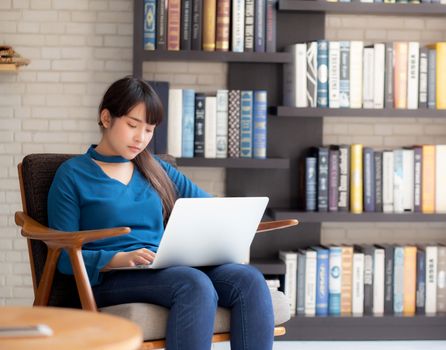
[144,0,278,52]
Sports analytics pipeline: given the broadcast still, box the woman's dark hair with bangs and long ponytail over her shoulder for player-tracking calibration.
[99,76,176,223]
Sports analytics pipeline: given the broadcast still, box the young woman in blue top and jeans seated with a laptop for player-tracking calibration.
[48,77,274,350]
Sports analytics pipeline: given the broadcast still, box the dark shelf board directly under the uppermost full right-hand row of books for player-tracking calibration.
[271,106,446,118]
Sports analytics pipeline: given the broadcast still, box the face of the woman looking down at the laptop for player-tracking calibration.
[103,102,155,160]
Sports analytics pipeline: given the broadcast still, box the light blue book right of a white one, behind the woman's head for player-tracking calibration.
[181,89,195,158]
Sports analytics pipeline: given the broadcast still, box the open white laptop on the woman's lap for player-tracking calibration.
[110,197,269,270]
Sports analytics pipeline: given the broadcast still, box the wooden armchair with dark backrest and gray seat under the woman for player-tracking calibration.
[15,154,297,349]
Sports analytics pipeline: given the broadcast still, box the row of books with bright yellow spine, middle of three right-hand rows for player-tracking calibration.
[305,144,446,214]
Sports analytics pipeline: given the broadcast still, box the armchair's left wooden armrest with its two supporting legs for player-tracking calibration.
[15,212,130,311]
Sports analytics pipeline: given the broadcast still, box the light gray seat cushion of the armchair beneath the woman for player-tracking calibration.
[100,291,290,340]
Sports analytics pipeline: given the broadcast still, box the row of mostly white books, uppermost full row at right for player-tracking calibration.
[283,40,446,109]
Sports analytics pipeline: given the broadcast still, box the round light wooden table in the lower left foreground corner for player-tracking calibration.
[0,307,142,350]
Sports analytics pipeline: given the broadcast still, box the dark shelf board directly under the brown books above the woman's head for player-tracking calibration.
[141,50,291,63]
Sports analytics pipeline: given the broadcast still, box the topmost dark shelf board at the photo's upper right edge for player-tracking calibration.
[279,0,446,16]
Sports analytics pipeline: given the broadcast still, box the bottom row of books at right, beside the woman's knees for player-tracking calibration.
[278,244,446,316]
